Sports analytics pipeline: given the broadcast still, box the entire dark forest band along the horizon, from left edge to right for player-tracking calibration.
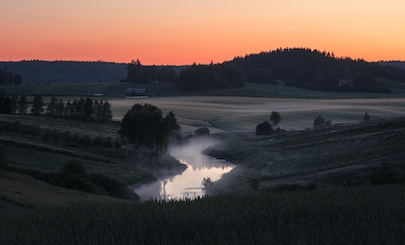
[0,48,405,91]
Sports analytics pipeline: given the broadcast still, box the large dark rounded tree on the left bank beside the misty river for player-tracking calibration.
[118,104,178,158]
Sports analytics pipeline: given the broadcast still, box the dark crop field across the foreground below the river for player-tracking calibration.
[0,185,405,245]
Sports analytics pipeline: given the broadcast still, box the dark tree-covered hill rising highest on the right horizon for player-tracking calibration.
[231,48,405,86]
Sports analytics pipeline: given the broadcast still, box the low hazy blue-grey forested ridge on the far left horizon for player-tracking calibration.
[0,60,128,84]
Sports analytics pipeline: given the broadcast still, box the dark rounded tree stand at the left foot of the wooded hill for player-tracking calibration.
[176,63,245,91]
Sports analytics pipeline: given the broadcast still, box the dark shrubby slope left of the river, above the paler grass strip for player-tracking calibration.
[0,113,184,200]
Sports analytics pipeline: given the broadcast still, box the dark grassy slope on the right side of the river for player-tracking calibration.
[206,115,405,193]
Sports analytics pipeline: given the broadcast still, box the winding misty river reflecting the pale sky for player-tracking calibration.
[134,139,235,200]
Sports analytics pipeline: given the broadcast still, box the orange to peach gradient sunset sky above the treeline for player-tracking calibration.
[0,0,405,65]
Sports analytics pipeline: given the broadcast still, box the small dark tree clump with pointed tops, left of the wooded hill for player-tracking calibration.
[121,60,177,84]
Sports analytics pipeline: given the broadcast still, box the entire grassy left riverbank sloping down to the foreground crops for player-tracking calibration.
[0,115,186,207]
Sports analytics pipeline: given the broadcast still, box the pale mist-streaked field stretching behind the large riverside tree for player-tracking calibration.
[110,96,405,134]
